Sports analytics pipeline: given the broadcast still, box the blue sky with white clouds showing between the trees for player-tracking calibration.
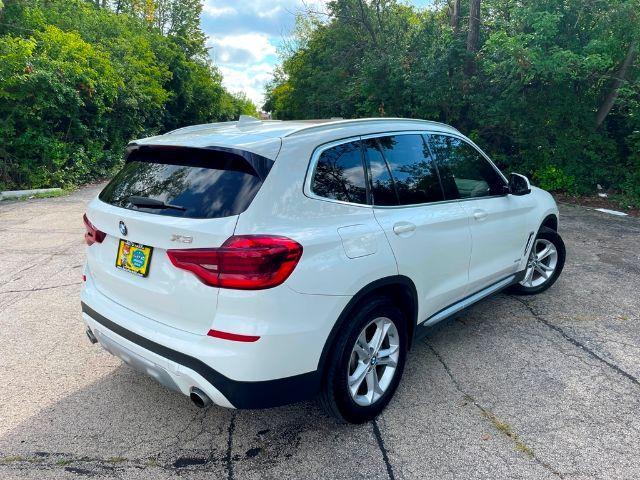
[202,0,432,107]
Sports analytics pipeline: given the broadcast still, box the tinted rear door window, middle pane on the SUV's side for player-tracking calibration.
[367,135,444,205]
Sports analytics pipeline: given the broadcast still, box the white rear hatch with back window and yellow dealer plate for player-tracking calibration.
[87,146,272,334]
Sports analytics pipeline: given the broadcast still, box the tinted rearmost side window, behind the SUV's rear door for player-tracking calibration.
[311,142,367,204]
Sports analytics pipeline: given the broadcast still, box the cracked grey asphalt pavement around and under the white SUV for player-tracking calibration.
[0,185,640,480]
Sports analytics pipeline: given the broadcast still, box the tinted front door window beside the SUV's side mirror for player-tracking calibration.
[429,135,505,200]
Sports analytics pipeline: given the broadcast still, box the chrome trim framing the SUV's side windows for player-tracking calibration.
[303,128,509,209]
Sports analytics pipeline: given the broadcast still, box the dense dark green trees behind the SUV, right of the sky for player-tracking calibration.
[265,0,640,202]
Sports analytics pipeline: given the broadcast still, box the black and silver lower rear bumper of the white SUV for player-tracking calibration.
[82,302,320,408]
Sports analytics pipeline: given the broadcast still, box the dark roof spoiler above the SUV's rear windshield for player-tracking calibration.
[125,143,274,181]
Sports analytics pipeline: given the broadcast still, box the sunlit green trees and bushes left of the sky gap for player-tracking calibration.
[0,0,256,190]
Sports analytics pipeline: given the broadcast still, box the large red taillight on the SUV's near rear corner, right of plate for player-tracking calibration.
[167,235,302,290]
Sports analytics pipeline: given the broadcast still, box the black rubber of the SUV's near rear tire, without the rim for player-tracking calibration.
[320,297,408,424]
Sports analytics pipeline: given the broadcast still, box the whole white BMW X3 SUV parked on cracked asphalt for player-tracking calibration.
[82,117,565,423]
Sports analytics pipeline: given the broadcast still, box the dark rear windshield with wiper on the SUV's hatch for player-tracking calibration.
[99,149,270,218]
